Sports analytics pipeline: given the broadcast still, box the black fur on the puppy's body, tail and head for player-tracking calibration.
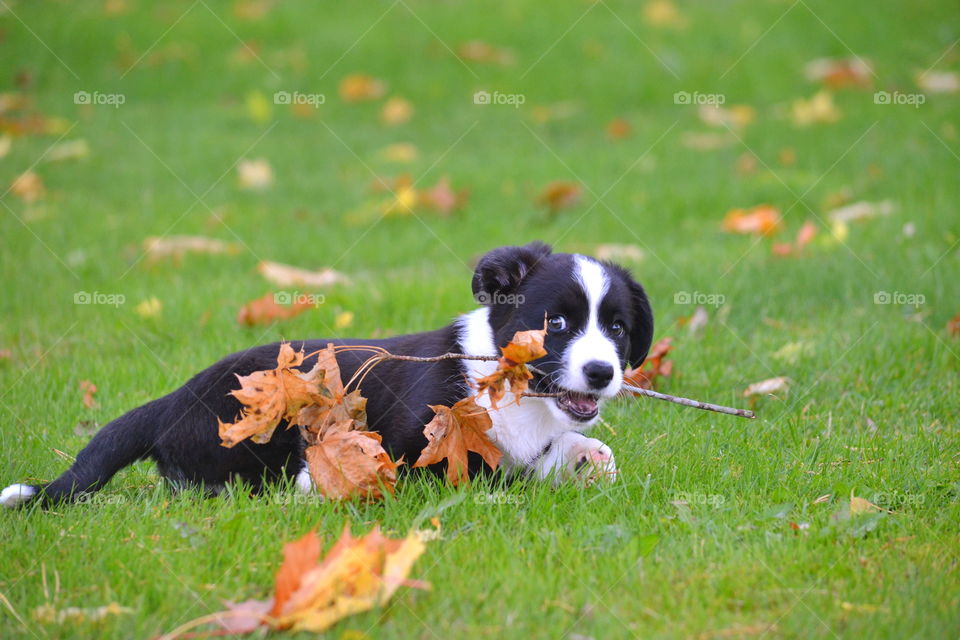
[3,243,653,504]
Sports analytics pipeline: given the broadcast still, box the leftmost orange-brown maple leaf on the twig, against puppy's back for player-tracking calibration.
[217,342,332,448]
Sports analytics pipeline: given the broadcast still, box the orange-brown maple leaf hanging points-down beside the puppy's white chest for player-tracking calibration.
[413,397,503,485]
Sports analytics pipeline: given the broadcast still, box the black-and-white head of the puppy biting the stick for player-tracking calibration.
[473,242,653,424]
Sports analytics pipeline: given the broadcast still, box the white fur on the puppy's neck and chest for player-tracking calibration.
[457,307,586,470]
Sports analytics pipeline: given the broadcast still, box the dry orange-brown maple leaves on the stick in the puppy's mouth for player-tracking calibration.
[217,328,547,500]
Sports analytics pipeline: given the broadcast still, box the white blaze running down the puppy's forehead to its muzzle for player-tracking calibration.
[563,256,623,397]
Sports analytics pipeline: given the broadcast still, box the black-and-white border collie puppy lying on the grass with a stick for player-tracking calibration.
[0,242,653,507]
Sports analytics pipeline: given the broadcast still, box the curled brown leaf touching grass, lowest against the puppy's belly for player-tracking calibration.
[305,431,403,500]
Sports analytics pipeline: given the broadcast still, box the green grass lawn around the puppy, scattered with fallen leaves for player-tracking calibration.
[0,0,960,638]
